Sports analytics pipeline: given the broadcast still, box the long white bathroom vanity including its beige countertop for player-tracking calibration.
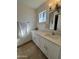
[32,30,61,59]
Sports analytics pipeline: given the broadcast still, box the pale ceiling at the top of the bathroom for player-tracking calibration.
[17,0,47,8]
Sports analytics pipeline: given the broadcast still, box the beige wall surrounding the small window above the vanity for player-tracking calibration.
[36,1,49,30]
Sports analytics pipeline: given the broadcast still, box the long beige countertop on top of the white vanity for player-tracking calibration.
[33,30,61,46]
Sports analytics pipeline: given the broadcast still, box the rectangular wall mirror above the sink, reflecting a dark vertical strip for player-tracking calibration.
[49,11,60,30]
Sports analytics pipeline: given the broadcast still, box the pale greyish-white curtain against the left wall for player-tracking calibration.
[17,22,27,38]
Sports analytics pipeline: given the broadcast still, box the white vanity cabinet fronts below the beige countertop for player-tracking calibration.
[32,32,60,59]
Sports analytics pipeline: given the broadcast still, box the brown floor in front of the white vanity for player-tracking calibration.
[17,41,47,59]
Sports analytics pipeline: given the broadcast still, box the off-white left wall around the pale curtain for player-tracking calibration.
[17,0,36,45]
